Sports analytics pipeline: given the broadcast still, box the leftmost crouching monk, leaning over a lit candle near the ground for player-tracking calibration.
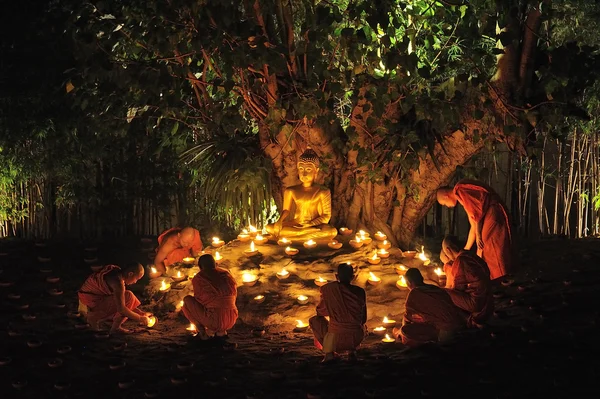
[77,262,151,333]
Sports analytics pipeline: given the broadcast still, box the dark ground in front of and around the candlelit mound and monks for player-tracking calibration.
[0,239,600,398]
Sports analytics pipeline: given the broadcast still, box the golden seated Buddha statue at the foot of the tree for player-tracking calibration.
[267,147,337,243]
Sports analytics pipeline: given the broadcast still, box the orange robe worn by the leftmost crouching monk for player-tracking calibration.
[77,265,140,321]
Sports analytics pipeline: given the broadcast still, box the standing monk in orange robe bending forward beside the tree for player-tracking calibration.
[437,179,513,280]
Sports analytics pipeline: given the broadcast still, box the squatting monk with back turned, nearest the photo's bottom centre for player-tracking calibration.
[309,263,367,362]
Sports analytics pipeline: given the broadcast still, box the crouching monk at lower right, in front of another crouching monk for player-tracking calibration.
[393,268,467,347]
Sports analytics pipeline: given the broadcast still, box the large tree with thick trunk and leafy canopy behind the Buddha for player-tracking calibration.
[69,0,589,244]
